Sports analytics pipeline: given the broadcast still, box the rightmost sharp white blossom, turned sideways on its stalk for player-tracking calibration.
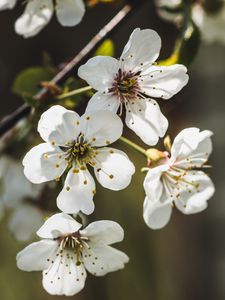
[144,128,214,229]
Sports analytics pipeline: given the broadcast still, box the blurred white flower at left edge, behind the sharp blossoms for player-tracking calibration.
[0,156,44,242]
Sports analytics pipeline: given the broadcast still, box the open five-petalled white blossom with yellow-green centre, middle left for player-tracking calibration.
[23,105,135,214]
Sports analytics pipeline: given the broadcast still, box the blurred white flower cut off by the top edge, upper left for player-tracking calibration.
[0,0,85,38]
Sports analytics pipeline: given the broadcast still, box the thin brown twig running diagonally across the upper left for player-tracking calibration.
[0,0,146,139]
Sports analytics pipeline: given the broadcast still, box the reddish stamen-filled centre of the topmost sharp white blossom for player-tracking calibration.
[109,69,140,102]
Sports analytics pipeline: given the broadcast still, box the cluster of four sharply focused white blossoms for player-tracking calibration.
[3,26,214,296]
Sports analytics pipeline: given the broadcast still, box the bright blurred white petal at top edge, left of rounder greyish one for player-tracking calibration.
[15,0,54,38]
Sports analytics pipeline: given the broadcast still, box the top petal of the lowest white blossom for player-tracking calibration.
[37,213,82,239]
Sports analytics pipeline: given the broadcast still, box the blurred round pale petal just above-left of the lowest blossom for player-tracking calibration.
[9,204,44,242]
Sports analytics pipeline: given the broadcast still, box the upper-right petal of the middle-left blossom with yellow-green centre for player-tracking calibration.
[81,111,123,147]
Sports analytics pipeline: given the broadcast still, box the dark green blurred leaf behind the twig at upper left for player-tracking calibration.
[12,67,54,97]
